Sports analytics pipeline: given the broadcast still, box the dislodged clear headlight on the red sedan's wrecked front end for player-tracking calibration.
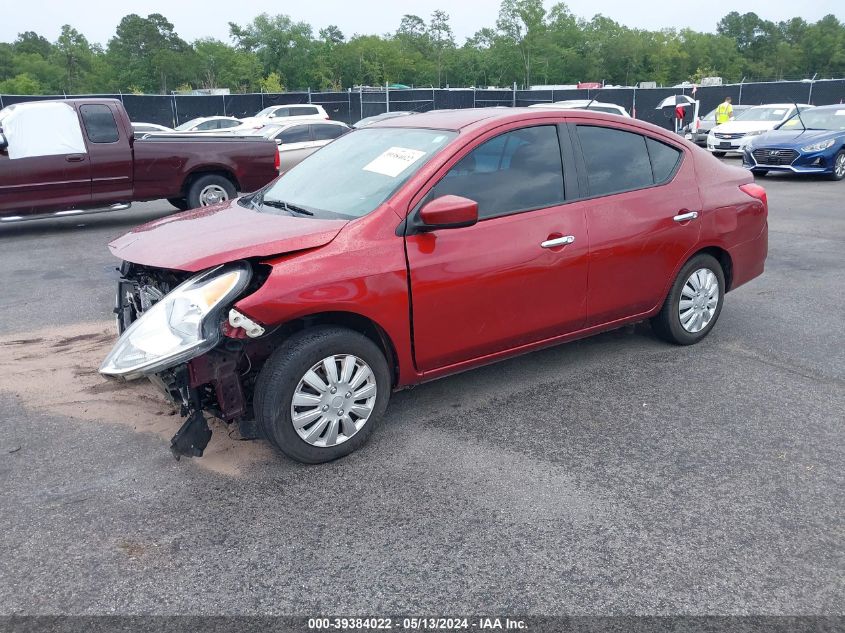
[100,263,252,380]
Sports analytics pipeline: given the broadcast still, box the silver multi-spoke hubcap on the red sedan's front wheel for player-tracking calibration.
[290,354,378,448]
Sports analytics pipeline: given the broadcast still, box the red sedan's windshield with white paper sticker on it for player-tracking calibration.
[254,128,456,219]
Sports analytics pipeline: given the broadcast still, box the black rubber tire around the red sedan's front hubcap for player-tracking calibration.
[253,326,392,464]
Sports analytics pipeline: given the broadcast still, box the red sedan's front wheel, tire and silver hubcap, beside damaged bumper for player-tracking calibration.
[253,326,391,464]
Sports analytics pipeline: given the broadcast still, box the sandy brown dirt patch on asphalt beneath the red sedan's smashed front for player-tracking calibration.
[0,323,273,475]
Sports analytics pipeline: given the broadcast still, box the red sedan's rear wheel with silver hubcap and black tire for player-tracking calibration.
[651,253,725,345]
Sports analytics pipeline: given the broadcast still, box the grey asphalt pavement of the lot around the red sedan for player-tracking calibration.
[0,170,845,615]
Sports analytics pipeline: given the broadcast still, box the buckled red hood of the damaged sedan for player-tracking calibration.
[109,200,348,272]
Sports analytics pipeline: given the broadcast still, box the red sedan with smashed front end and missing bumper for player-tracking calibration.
[100,109,767,463]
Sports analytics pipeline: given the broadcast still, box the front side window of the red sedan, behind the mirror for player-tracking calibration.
[428,125,564,219]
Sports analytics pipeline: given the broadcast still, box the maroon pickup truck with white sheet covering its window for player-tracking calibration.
[0,99,279,222]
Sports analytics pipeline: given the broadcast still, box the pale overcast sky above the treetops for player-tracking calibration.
[0,0,845,45]
